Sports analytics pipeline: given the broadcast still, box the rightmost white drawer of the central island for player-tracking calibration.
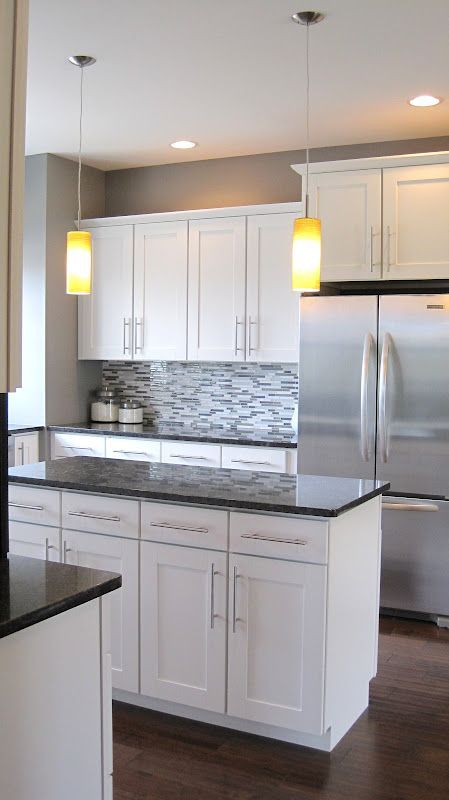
[230,512,328,564]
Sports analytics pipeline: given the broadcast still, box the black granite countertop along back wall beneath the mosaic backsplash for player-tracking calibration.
[48,422,298,448]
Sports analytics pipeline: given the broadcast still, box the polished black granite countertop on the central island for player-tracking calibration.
[9,456,390,517]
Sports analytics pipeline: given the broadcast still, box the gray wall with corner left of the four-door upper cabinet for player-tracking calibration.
[9,155,105,432]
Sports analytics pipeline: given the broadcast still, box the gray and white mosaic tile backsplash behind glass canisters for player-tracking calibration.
[103,361,298,435]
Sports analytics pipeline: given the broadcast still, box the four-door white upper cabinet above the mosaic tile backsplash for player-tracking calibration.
[78,204,301,362]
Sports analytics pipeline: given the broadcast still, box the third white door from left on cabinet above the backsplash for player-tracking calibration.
[188,217,246,361]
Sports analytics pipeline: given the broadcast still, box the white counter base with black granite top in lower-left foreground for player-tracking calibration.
[0,555,121,800]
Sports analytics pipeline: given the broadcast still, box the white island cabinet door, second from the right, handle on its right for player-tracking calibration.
[141,542,226,712]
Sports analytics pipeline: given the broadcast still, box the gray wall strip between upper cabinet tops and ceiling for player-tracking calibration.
[106,136,449,216]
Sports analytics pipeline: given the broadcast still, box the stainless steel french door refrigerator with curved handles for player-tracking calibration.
[298,294,449,616]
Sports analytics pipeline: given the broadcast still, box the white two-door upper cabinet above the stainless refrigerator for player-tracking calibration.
[295,153,449,282]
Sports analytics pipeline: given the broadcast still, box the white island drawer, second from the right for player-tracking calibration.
[141,502,228,550]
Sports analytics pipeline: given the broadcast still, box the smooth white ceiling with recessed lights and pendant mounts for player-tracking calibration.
[27,0,449,169]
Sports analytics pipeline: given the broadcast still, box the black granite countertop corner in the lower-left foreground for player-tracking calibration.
[0,555,122,639]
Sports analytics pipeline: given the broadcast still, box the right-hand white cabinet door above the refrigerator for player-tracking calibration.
[383,164,449,280]
